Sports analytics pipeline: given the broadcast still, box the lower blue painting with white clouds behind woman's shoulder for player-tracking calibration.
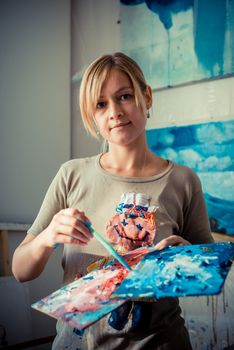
[147,120,234,237]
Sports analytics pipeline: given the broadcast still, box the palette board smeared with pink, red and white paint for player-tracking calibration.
[32,247,152,330]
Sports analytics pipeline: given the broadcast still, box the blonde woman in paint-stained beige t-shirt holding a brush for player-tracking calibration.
[13,53,213,350]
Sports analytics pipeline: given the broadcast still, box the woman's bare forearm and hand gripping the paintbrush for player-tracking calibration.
[12,208,93,282]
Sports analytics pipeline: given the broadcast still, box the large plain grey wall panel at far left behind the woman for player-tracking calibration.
[0,0,70,223]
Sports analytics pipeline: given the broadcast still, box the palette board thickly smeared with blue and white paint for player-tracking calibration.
[112,243,234,299]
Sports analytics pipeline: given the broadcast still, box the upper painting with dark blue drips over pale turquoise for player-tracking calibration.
[120,0,234,89]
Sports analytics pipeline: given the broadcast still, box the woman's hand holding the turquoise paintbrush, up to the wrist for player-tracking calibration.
[41,208,93,248]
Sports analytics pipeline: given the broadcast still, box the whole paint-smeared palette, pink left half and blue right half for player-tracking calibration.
[32,243,234,330]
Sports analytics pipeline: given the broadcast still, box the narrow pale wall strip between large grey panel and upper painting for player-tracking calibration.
[71,0,121,158]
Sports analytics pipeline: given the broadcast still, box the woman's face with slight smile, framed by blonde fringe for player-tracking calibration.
[94,69,151,146]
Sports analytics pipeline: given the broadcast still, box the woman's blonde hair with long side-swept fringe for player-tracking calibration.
[79,52,147,138]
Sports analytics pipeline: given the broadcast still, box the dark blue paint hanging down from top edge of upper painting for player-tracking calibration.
[120,0,230,77]
